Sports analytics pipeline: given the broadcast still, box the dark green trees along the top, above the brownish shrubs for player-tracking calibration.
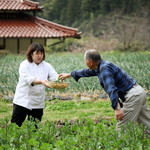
[35,0,150,26]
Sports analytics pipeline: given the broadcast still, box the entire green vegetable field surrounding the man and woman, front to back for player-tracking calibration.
[0,52,150,150]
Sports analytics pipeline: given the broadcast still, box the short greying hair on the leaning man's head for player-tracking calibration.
[84,49,101,62]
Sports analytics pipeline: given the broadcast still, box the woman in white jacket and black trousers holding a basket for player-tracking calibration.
[11,43,58,127]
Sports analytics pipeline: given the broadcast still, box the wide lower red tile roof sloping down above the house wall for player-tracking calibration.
[0,13,81,38]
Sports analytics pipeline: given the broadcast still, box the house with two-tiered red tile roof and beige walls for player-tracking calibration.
[0,0,81,53]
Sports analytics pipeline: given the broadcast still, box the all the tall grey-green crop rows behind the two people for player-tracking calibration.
[0,52,150,95]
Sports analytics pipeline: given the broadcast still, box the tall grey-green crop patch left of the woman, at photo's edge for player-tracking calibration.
[0,55,24,96]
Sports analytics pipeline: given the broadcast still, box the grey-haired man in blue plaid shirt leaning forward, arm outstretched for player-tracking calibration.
[59,50,150,134]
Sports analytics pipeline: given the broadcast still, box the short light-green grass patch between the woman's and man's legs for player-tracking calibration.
[44,100,114,121]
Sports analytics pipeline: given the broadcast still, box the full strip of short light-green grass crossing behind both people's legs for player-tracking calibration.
[0,98,150,123]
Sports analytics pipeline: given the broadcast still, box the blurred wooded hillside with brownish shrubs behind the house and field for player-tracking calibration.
[34,0,150,51]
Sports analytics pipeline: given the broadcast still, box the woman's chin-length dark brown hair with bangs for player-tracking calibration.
[26,43,45,63]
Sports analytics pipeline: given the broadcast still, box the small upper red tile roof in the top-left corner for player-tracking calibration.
[0,0,43,10]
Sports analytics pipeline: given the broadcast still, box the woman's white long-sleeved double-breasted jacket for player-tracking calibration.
[13,60,58,109]
